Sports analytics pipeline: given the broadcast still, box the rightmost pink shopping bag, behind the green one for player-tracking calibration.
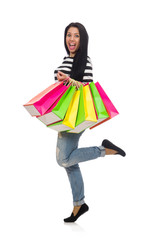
[90,82,119,129]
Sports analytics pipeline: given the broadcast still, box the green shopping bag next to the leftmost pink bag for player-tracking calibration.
[45,86,75,129]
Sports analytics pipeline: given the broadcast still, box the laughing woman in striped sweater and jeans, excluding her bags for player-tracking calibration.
[55,23,125,222]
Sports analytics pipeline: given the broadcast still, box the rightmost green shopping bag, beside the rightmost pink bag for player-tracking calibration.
[89,82,109,126]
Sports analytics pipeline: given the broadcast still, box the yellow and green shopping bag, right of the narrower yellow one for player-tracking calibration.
[69,84,97,133]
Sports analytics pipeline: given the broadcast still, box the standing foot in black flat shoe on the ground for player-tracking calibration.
[64,203,89,222]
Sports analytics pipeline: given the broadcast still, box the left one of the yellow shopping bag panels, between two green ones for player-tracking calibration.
[63,90,80,129]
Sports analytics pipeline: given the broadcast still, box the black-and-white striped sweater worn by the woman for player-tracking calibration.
[54,56,93,82]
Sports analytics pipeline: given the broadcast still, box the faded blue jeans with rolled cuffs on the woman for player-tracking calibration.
[56,131,105,206]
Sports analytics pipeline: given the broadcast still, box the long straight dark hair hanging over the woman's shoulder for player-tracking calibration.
[64,22,89,81]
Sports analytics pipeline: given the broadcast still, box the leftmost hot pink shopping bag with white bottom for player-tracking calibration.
[23,82,66,116]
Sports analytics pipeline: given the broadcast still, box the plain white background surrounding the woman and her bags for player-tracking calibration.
[0,0,159,240]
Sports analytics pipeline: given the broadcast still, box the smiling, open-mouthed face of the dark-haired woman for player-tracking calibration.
[66,27,80,57]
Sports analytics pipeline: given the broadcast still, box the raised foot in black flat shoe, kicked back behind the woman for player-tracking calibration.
[102,139,126,157]
